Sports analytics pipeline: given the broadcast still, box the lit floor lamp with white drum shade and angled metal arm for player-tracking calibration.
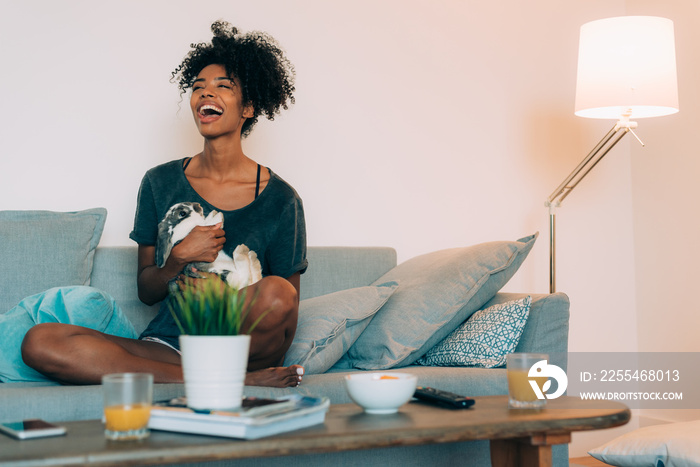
[545,16,678,293]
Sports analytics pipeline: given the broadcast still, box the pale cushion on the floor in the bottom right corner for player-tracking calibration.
[588,420,700,467]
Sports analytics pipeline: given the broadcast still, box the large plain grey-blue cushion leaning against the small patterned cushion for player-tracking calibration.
[338,234,537,370]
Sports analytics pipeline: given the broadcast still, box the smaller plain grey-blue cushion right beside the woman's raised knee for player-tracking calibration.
[284,282,397,374]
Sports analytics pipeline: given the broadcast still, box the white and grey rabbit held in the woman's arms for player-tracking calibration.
[156,203,262,289]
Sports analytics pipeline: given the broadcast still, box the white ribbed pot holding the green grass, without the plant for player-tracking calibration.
[180,335,250,410]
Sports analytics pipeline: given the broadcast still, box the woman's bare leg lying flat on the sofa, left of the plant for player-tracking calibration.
[22,323,182,384]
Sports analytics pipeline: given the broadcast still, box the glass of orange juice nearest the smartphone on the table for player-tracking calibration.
[102,373,153,440]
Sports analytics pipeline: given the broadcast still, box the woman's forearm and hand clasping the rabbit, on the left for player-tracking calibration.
[137,224,226,305]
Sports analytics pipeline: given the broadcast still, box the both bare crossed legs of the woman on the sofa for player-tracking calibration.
[22,276,304,387]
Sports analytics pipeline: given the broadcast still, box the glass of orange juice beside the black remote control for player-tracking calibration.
[506,353,549,409]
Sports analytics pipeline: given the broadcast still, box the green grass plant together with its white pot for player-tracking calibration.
[170,277,263,410]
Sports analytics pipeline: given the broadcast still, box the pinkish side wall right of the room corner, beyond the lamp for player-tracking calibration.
[629,0,700,430]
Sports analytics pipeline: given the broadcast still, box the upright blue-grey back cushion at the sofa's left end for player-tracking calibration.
[0,208,107,313]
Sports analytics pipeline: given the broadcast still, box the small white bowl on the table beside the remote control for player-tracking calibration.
[345,372,416,414]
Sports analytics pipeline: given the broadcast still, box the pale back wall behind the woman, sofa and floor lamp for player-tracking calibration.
[5,0,698,458]
